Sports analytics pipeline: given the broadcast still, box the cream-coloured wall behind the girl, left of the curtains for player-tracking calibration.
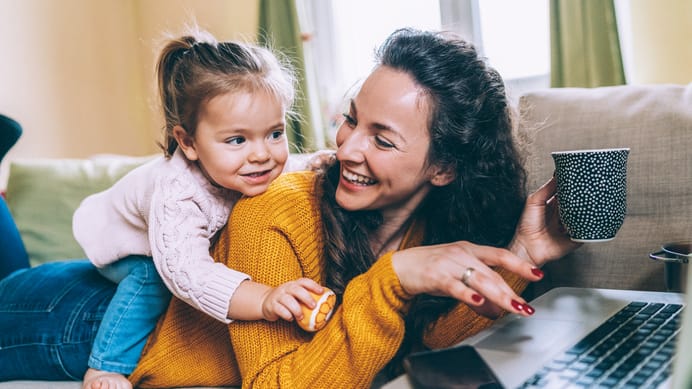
[0,0,258,188]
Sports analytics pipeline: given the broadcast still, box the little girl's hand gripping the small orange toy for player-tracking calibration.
[262,278,324,321]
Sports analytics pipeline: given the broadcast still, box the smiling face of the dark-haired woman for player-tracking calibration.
[336,67,446,220]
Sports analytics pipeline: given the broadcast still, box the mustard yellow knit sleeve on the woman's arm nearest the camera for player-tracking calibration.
[214,173,410,388]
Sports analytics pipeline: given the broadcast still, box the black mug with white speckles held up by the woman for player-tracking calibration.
[551,148,630,242]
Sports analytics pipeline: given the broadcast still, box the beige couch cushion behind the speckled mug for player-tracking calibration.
[519,84,692,293]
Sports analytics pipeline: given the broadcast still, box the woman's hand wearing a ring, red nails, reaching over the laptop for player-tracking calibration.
[392,241,543,316]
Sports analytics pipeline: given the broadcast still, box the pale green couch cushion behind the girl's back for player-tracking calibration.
[6,155,152,265]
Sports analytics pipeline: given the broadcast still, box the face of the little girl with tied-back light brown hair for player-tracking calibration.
[174,91,288,196]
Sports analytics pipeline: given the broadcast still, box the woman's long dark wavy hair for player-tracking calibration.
[317,29,526,374]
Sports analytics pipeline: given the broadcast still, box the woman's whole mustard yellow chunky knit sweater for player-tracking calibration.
[130,172,526,389]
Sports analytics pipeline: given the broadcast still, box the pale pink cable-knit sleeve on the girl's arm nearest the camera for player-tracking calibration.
[148,174,249,323]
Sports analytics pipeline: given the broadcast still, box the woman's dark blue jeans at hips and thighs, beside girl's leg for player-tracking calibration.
[0,260,116,381]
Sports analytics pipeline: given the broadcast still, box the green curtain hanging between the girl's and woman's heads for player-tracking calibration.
[258,0,316,152]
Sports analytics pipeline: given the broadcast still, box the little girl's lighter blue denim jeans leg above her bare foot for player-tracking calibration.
[89,255,171,375]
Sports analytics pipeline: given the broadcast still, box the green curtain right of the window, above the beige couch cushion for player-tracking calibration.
[550,0,625,87]
